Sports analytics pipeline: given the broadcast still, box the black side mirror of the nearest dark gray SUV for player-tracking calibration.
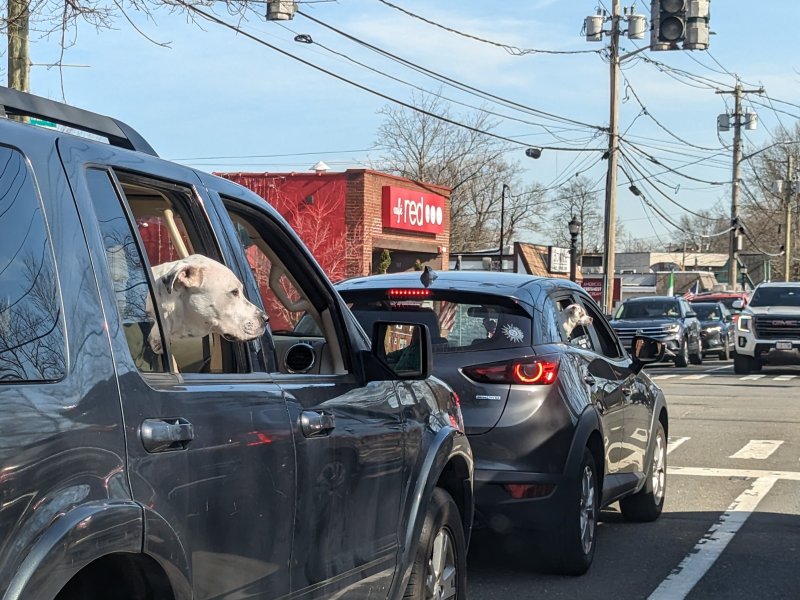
[371,321,433,380]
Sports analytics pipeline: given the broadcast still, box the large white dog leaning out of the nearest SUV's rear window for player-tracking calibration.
[147,254,269,354]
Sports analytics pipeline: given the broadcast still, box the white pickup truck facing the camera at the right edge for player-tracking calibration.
[733,282,800,375]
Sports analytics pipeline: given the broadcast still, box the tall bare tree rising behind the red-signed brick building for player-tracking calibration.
[376,94,541,253]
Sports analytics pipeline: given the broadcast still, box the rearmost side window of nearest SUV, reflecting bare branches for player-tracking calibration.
[0,147,66,383]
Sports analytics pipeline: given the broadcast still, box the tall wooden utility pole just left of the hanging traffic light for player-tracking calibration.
[603,0,620,314]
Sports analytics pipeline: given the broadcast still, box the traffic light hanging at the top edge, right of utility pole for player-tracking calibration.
[650,0,710,50]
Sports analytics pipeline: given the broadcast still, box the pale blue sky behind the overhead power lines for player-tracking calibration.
[25,0,800,246]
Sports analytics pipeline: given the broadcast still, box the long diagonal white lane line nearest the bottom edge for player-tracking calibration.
[648,476,778,600]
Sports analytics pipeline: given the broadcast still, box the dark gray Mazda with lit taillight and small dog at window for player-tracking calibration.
[336,271,669,574]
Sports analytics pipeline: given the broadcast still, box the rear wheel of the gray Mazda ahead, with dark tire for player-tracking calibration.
[548,448,600,575]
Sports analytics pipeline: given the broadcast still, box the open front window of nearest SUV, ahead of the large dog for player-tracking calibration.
[223,204,349,375]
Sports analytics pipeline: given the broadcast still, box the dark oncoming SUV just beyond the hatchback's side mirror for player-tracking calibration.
[611,296,703,367]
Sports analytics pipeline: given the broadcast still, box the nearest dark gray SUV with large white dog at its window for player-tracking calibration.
[0,88,473,600]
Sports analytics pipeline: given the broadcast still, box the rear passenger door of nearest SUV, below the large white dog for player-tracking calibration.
[60,139,295,598]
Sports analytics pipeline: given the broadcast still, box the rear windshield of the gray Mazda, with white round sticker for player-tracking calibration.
[341,290,532,354]
